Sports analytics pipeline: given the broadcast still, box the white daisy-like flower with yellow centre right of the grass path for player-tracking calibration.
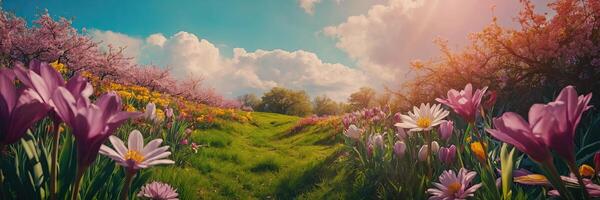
[395,104,449,132]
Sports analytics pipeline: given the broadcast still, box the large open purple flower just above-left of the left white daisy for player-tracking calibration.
[52,87,139,168]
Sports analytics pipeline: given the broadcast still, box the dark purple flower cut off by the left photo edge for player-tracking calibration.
[0,69,50,145]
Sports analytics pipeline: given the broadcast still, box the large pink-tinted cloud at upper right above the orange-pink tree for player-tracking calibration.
[322,0,540,84]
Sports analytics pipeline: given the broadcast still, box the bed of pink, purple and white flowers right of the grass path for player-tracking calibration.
[343,84,600,199]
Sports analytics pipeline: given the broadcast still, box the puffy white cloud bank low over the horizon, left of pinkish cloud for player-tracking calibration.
[93,31,367,100]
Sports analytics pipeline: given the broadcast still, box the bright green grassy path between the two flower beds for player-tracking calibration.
[150,112,341,199]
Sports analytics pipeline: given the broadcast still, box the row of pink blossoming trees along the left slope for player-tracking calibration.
[0,10,234,107]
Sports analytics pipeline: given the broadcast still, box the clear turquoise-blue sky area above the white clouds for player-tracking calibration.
[3,0,382,65]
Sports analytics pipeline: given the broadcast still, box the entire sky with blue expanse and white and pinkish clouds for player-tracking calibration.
[2,0,545,101]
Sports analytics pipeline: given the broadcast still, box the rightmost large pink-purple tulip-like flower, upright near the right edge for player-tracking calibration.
[529,86,592,163]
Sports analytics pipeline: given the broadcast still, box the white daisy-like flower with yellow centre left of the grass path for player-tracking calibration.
[100,130,175,171]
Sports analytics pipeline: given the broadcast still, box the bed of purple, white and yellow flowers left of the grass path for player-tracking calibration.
[0,61,252,199]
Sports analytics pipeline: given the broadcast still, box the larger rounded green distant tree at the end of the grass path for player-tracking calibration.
[259,87,312,116]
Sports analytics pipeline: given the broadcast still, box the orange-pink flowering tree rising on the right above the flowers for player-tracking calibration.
[403,0,600,111]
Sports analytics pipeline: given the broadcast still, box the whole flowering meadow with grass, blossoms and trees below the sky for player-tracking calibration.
[0,0,600,200]
